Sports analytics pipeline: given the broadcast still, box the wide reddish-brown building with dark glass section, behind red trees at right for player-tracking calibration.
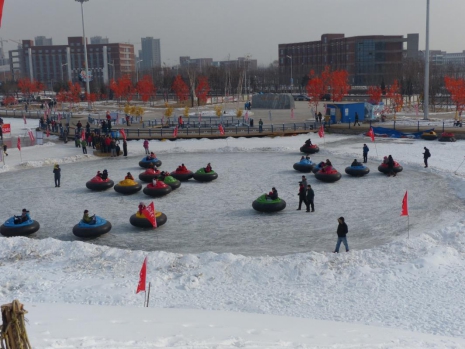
[278,34,419,85]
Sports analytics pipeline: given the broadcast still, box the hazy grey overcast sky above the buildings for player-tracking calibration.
[0,0,465,66]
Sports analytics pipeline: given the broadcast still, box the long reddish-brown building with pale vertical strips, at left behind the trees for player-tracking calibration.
[9,36,135,87]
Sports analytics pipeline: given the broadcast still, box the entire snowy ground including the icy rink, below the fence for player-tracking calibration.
[0,118,465,349]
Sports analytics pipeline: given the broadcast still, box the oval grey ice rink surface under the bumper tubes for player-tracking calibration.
[0,149,462,255]
